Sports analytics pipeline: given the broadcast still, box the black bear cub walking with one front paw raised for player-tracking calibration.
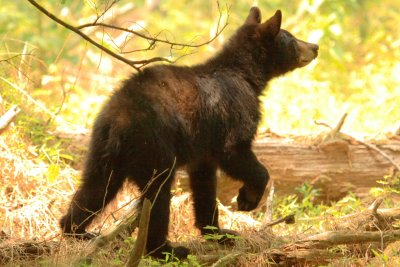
[61,7,318,258]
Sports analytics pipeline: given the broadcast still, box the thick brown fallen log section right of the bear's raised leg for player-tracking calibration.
[253,138,400,200]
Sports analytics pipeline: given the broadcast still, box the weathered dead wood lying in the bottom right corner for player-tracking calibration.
[270,201,400,265]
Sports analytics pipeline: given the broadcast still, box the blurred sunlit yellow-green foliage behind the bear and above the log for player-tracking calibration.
[0,0,400,137]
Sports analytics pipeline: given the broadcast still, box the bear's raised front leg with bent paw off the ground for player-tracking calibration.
[220,144,269,211]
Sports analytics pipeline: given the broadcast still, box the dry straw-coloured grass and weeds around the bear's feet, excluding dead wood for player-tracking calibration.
[0,123,398,266]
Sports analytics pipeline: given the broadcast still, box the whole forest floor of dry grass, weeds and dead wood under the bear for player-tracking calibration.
[0,126,400,266]
